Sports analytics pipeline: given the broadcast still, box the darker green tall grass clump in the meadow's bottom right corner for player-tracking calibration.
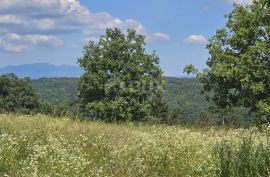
[216,136,270,177]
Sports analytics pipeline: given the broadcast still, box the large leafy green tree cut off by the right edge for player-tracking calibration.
[186,0,270,124]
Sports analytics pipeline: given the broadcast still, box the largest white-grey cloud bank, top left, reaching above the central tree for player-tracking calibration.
[0,0,136,34]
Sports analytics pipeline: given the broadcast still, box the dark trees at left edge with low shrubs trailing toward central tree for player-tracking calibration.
[0,74,77,116]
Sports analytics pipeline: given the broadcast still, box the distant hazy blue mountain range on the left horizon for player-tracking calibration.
[0,63,82,79]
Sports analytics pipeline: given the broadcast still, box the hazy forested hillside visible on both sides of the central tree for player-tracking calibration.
[31,77,207,114]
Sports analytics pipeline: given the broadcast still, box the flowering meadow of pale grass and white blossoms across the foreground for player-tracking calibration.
[0,115,270,177]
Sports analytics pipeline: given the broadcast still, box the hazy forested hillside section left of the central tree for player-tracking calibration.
[30,78,79,104]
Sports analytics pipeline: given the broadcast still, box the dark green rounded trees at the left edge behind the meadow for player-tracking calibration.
[0,74,40,113]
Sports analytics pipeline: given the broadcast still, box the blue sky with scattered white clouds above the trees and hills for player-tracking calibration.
[0,0,251,76]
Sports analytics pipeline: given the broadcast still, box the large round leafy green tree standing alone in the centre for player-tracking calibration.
[78,29,163,121]
